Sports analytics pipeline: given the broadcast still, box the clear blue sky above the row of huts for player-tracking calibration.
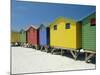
[11,0,96,31]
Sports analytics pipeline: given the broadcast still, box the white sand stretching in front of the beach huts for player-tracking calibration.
[11,47,95,74]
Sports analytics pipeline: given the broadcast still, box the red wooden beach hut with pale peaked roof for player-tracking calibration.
[25,25,39,49]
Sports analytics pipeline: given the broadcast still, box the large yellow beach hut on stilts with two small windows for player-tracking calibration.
[50,17,81,59]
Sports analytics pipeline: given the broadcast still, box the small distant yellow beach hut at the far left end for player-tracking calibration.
[11,31,20,46]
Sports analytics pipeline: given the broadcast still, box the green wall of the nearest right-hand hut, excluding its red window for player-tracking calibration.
[82,13,96,51]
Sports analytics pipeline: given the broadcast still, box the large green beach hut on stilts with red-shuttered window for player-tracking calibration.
[82,12,96,62]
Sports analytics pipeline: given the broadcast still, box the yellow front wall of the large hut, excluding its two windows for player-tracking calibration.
[50,19,79,49]
